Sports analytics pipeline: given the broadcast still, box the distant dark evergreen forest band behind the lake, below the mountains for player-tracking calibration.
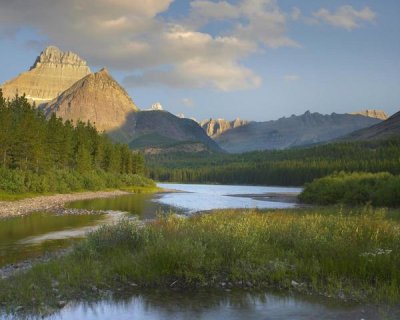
[146,138,400,186]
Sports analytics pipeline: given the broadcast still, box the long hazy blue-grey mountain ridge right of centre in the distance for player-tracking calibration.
[215,111,381,153]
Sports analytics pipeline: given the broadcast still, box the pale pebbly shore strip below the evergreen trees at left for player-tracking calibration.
[0,190,129,219]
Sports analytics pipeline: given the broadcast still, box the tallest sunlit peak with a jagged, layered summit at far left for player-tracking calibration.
[1,46,90,105]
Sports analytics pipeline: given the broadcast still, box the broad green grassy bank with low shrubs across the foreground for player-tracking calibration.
[0,207,400,310]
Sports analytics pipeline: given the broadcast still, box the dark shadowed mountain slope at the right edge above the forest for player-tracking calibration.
[341,111,400,140]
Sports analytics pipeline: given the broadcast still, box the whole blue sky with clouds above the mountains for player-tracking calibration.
[0,0,400,121]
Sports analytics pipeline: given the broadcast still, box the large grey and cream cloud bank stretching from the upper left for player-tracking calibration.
[0,0,278,91]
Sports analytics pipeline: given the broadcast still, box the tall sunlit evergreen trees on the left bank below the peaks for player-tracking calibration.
[0,90,152,193]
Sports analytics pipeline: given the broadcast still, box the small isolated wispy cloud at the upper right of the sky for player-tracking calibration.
[313,5,376,31]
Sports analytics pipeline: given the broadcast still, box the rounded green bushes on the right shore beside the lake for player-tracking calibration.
[299,172,400,207]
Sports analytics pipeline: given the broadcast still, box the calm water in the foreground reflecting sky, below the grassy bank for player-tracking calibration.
[48,290,400,320]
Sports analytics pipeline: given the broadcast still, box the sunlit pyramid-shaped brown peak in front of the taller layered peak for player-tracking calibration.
[40,69,138,131]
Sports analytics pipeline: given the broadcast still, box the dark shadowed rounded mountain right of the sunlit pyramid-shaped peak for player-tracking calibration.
[109,110,222,154]
